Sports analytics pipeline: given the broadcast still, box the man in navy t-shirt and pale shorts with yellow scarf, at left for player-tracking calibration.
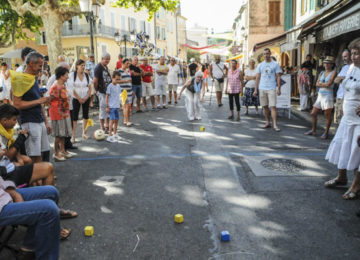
[14,51,51,163]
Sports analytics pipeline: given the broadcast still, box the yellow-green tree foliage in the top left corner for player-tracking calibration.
[0,0,43,48]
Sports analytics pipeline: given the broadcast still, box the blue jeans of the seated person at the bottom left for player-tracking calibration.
[0,186,60,260]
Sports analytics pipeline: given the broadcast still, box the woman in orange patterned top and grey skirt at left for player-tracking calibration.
[49,67,75,162]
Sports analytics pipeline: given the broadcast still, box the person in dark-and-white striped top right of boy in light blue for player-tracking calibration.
[119,59,133,126]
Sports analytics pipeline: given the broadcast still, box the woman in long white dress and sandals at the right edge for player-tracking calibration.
[325,41,360,200]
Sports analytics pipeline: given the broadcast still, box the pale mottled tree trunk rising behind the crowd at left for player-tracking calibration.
[41,10,63,73]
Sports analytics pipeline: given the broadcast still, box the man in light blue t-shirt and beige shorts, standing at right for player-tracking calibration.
[254,48,282,132]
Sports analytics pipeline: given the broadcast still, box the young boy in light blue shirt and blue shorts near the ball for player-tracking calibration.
[105,71,121,143]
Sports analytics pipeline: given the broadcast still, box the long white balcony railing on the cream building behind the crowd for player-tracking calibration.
[62,24,130,37]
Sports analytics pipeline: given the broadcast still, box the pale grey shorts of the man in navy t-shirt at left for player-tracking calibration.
[21,122,50,156]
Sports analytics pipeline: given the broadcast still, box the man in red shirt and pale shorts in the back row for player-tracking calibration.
[140,57,156,111]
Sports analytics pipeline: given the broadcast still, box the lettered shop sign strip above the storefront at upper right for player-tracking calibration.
[322,11,360,40]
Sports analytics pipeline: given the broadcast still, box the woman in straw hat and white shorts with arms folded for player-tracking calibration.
[305,56,336,139]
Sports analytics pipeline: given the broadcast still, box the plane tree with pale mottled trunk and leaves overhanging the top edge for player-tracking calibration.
[6,0,178,71]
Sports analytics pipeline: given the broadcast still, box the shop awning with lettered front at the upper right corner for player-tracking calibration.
[320,3,360,41]
